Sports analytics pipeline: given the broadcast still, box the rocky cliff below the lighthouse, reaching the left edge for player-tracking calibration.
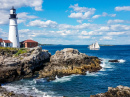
[0,47,51,83]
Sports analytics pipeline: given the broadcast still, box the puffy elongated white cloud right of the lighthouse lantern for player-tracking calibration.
[28,20,57,28]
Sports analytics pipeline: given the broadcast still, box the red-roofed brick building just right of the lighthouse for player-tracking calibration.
[22,40,38,48]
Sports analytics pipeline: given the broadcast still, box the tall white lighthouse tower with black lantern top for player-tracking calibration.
[9,7,20,48]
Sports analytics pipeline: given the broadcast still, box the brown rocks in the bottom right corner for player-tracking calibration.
[90,85,130,97]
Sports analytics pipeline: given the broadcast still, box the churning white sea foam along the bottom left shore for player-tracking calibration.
[2,79,63,97]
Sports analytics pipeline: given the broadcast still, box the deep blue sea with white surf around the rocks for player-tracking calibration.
[3,45,130,97]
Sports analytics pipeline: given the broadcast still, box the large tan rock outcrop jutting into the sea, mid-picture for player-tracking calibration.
[39,48,101,80]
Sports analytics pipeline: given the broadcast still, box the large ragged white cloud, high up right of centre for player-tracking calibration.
[68,4,96,19]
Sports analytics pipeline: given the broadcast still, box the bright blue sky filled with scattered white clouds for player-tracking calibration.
[0,0,130,45]
